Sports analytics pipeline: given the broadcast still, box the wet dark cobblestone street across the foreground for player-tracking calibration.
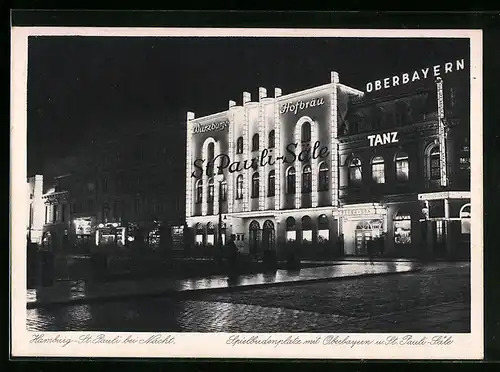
[27,263,470,332]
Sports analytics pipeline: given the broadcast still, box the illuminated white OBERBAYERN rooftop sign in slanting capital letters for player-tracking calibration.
[366,58,465,93]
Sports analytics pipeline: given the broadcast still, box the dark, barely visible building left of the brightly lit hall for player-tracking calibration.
[37,120,185,252]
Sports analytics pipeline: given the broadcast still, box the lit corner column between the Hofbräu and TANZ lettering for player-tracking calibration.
[330,71,339,207]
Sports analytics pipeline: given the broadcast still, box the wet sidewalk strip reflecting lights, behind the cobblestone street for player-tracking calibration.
[27,261,420,308]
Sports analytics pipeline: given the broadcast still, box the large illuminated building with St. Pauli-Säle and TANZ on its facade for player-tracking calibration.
[186,61,470,256]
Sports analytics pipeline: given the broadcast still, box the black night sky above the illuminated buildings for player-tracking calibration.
[28,37,469,175]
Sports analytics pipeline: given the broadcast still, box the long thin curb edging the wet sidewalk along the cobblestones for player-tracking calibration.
[26,268,421,309]
